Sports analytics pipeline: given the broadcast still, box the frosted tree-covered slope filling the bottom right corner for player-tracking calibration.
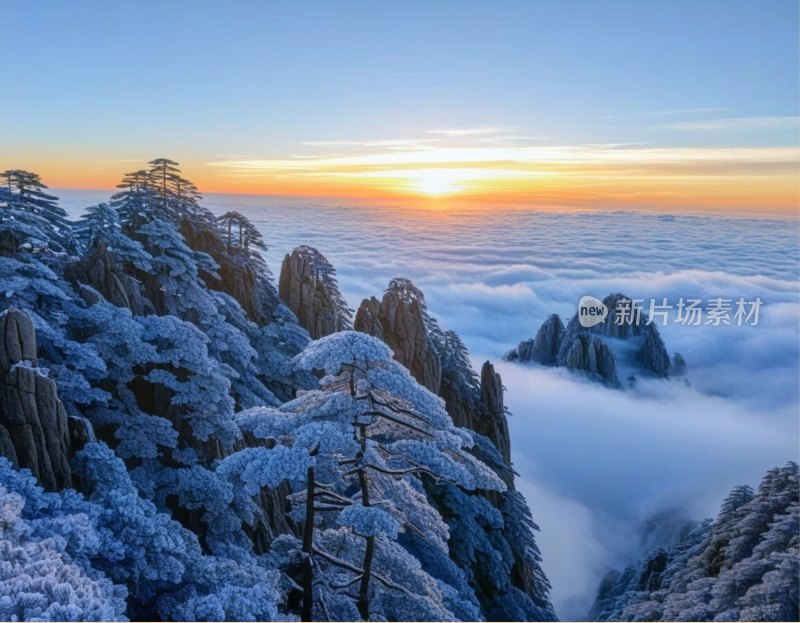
[590,463,800,621]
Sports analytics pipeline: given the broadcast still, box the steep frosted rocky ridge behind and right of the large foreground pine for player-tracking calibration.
[355,277,555,620]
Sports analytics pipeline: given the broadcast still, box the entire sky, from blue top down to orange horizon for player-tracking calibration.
[0,0,800,215]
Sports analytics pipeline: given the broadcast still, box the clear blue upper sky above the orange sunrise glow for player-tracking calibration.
[0,0,800,210]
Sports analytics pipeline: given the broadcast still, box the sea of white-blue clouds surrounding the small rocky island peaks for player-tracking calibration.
[61,191,800,620]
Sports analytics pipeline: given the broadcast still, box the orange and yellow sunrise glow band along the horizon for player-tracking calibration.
[0,146,800,216]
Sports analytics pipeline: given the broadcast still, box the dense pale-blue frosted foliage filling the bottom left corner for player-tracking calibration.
[0,443,282,621]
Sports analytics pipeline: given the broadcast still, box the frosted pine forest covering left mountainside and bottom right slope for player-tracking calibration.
[0,158,798,621]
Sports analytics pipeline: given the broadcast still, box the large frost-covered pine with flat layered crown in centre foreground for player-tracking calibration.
[226,331,505,620]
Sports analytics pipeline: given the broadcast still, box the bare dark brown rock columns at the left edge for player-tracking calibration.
[0,309,72,491]
